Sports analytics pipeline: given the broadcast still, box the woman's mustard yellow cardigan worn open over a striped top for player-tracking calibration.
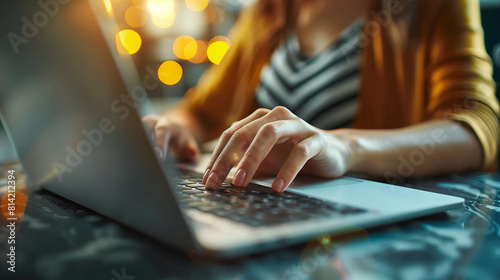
[180,0,499,170]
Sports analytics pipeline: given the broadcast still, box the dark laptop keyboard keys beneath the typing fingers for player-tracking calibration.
[175,174,367,227]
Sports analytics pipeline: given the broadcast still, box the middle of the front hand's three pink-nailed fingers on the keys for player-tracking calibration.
[233,119,317,187]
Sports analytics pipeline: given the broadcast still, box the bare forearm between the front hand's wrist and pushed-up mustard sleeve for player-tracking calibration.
[338,120,482,178]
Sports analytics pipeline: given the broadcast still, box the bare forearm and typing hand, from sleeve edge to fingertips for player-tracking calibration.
[203,107,482,192]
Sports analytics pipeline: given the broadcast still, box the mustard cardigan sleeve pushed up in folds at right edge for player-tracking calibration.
[427,0,499,169]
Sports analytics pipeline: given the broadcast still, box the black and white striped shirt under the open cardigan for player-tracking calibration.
[256,20,362,129]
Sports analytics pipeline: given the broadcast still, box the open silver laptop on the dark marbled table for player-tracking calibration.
[0,0,463,258]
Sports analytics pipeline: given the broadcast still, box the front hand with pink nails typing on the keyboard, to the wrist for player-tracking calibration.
[203,107,352,192]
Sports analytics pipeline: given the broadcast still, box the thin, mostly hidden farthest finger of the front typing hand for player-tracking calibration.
[202,109,270,184]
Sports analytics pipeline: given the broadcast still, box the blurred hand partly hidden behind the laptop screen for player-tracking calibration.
[142,115,200,162]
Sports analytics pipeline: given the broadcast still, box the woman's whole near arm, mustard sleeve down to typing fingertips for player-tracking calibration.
[204,0,499,192]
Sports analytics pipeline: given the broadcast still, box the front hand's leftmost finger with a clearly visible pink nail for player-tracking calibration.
[205,107,297,189]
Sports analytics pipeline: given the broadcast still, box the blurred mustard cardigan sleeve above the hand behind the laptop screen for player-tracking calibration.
[176,0,289,141]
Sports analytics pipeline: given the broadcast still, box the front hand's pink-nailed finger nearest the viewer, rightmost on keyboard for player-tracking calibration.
[271,137,321,192]
